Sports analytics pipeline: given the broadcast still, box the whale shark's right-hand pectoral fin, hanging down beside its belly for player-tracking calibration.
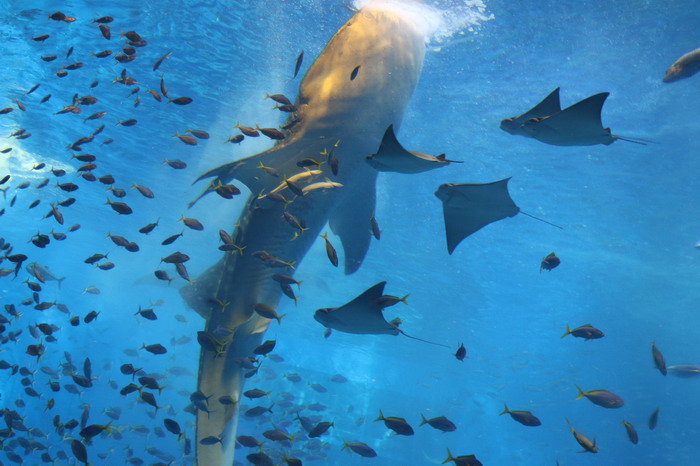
[329,176,376,275]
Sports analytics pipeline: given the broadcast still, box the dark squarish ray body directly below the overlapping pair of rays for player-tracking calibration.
[435,178,520,254]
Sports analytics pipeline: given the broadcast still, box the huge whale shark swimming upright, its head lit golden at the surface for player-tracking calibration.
[180,3,426,466]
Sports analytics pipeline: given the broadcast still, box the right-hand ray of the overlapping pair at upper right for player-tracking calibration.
[540,92,610,138]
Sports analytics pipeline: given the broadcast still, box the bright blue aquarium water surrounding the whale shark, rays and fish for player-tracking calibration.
[0,0,700,466]
